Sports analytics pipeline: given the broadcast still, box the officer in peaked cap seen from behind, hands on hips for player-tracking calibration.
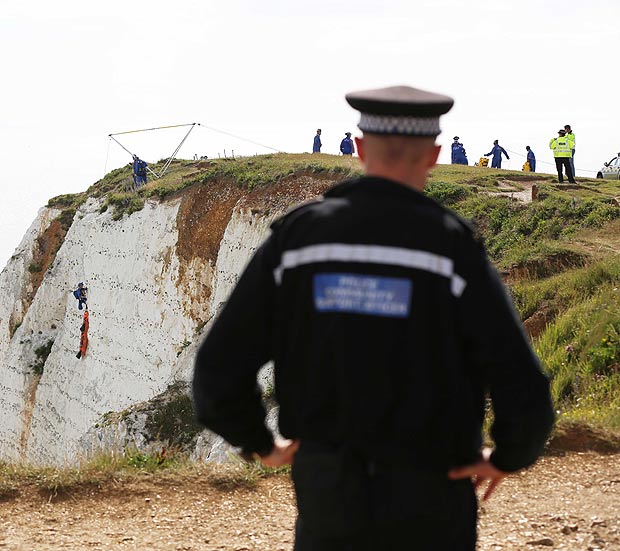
[193,86,553,551]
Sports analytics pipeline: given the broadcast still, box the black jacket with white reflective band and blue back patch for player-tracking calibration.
[194,177,554,471]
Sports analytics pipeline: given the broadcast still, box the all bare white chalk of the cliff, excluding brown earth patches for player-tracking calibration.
[0,182,300,464]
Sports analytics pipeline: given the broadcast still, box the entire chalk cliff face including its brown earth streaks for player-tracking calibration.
[0,165,335,464]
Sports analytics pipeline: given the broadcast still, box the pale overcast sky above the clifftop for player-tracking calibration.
[0,0,620,268]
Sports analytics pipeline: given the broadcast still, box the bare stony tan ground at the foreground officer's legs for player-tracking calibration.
[0,452,620,551]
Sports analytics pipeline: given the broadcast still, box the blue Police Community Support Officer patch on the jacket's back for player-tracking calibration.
[314,273,413,318]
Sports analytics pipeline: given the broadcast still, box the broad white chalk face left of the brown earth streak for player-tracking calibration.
[0,201,195,462]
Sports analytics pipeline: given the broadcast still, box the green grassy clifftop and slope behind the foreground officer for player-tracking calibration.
[49,154,620,431]
